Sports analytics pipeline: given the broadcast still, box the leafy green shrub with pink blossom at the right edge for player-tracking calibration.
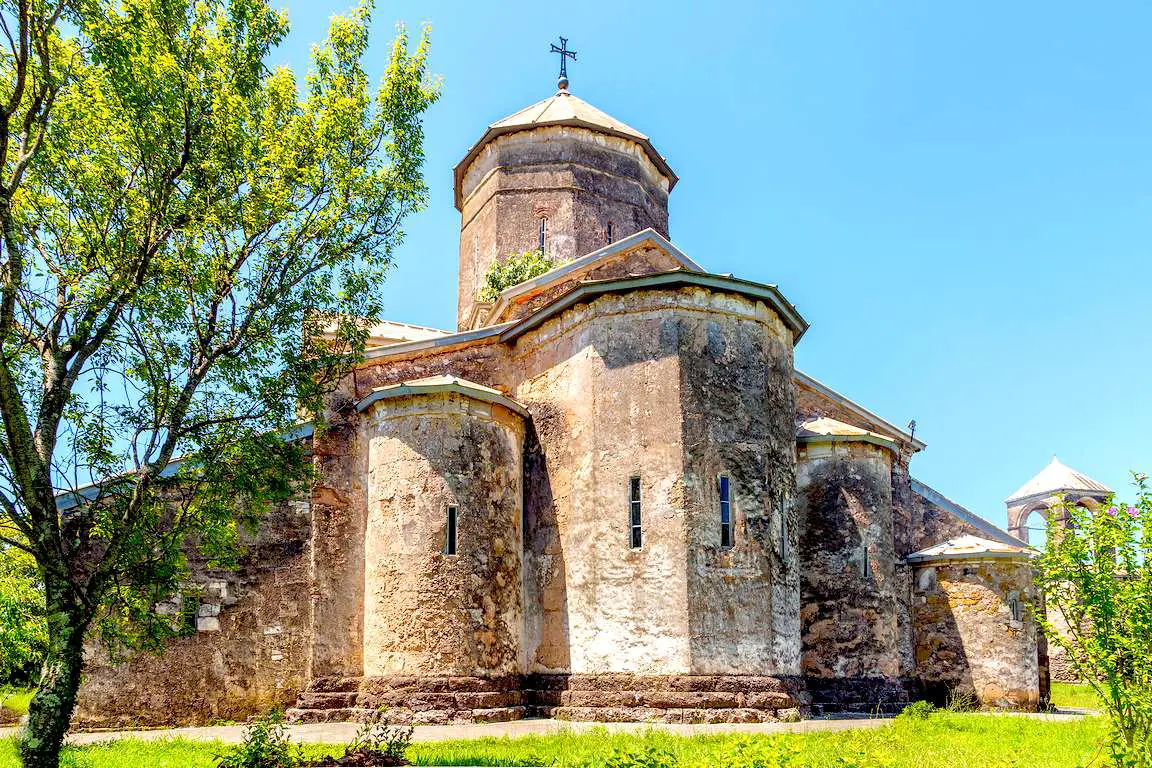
[1039,474,1152,768]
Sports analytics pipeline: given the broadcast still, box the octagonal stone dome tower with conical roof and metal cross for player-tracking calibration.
[454,56,676,330]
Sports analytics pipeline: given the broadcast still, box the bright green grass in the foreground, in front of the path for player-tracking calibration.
[0,713,1105,768]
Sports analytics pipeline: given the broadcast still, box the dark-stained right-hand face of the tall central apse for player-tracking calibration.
[664,291,799,675]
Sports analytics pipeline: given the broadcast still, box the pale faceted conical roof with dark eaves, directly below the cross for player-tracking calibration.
[453,90,677,208]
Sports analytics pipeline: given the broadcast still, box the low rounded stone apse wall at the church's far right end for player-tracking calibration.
[914,558,1040,709]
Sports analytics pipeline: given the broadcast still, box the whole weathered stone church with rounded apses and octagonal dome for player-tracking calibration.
[77,81,1047,725]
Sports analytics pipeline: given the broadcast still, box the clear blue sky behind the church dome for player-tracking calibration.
[271,0,1152,525]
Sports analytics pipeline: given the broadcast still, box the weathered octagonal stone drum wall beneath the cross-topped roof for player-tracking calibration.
[457,126,668,328]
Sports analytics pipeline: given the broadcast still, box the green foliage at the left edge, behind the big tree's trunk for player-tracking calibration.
[0,546,48,689]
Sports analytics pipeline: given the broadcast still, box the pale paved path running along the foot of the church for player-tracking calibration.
[0,712,1091,744]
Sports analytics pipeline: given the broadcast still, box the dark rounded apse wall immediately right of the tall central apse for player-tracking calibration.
[796,441,905,704]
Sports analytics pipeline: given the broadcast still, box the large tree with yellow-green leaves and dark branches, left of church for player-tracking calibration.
[0,0,437,768]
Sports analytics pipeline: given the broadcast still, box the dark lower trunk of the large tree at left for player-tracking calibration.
[20,607,88,768]
